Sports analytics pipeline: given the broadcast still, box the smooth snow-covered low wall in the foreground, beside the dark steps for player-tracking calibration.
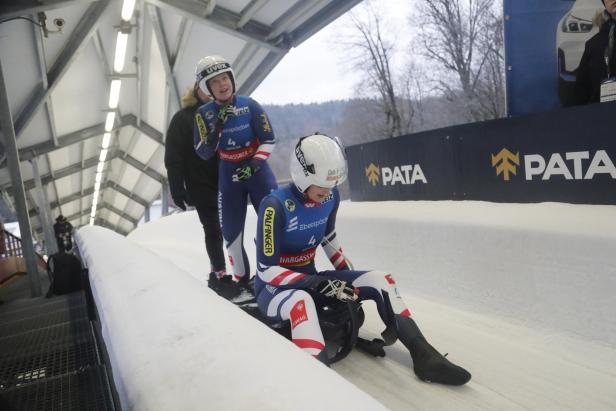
[76,226,384,411]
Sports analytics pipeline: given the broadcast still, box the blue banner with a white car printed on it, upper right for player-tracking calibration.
[503,0,604,116]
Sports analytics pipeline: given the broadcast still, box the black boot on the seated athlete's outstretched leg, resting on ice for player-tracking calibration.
[396,315,471,385]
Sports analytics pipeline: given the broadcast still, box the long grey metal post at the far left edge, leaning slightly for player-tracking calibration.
[0,60,42,297]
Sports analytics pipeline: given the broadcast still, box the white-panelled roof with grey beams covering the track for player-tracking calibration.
[0,0,360,238]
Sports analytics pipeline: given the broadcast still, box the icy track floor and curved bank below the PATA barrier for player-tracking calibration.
[129,201,616,410]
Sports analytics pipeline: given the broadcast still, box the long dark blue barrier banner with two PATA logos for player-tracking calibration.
[347,102,616,204]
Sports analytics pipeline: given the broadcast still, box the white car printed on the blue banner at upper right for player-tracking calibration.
[556,0,605,105]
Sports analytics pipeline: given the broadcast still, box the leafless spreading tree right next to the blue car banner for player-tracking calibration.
[412,0,503,121]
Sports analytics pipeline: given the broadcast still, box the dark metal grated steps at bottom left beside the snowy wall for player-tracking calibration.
[0,291,118,411]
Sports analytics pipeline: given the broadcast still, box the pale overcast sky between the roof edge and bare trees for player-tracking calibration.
[252,0,411,104]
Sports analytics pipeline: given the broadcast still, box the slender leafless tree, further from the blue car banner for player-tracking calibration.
[345,2,409,137]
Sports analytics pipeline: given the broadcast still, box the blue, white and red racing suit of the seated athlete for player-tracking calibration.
[255,184,410,356]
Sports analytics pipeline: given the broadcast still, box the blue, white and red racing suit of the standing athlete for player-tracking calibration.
[193,96,277,280]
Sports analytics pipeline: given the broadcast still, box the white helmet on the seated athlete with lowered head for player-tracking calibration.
[291,134,347,192]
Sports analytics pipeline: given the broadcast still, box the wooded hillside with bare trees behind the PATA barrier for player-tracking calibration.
[263,0,506,180]
